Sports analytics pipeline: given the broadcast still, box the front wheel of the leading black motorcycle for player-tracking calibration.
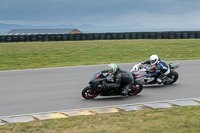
[82,86,99,99]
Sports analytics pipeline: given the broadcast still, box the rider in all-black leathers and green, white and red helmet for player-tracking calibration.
[98,63,134,96]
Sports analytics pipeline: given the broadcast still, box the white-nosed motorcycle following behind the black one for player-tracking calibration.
[131,63,181,85]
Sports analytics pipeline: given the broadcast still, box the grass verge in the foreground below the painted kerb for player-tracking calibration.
[0,106,200,133]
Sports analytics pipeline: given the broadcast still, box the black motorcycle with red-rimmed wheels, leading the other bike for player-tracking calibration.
[82,71,143,99]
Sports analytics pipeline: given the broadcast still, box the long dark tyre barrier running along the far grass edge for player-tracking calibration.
[0,31,200,42]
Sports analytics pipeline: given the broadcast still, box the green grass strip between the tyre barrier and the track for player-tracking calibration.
[0,39,200,70]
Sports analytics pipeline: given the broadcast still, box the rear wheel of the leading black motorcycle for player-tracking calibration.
[128,82,143,96]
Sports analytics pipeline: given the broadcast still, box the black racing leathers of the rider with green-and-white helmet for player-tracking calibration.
[100,67,134,95]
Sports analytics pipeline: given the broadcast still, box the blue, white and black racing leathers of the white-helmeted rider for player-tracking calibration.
[142,59,170,84]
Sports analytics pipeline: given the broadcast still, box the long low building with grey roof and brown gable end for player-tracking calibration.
[5,29,82,35]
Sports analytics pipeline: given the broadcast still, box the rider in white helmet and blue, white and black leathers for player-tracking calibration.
[141,55,170,84]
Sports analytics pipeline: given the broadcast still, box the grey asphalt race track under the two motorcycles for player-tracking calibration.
[0,60,200,116]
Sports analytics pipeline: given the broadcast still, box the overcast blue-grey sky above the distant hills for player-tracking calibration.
[0,0,200,28]
